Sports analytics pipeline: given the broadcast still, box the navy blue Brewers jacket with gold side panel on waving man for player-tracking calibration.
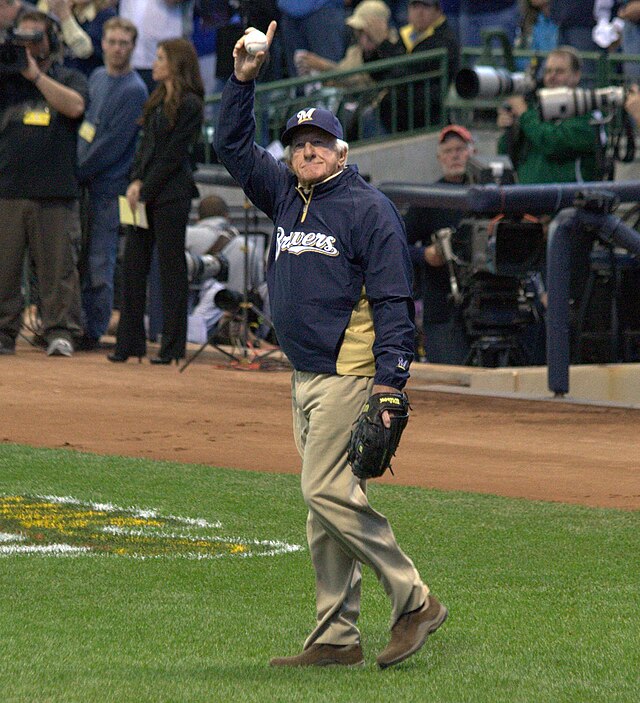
[215,76,414,389]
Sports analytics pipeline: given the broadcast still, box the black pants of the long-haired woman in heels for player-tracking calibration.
[116,200,191,359]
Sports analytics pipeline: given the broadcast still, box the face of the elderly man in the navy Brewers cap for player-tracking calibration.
[291,126,347,186]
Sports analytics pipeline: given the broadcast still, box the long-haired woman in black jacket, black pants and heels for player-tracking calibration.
[108,39,204,364]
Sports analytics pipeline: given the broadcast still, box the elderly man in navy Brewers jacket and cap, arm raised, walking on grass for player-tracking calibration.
[215,22,447,668]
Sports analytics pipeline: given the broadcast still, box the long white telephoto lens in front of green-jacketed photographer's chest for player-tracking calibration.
[538,86,625,121]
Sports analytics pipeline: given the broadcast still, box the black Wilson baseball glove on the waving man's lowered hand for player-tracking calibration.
[347,391,409,479]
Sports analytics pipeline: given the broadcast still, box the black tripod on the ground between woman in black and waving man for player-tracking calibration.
[180,196,276,373]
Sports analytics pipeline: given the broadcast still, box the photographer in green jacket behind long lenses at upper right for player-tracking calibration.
[497,47,602,184]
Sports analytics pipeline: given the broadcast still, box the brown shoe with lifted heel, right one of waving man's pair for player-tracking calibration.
[376,596,448,669]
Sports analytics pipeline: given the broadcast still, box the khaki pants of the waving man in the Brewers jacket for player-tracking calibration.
[292,371,429,648]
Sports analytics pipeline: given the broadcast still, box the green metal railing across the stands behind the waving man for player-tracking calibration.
[198,38,640,163]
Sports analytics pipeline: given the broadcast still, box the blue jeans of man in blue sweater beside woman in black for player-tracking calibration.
[82,190,120,339]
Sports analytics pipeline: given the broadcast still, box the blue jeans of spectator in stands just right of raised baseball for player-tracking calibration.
[279,7,347,76]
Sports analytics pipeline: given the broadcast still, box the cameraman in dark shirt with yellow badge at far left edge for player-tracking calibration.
[0,11,87,356]
